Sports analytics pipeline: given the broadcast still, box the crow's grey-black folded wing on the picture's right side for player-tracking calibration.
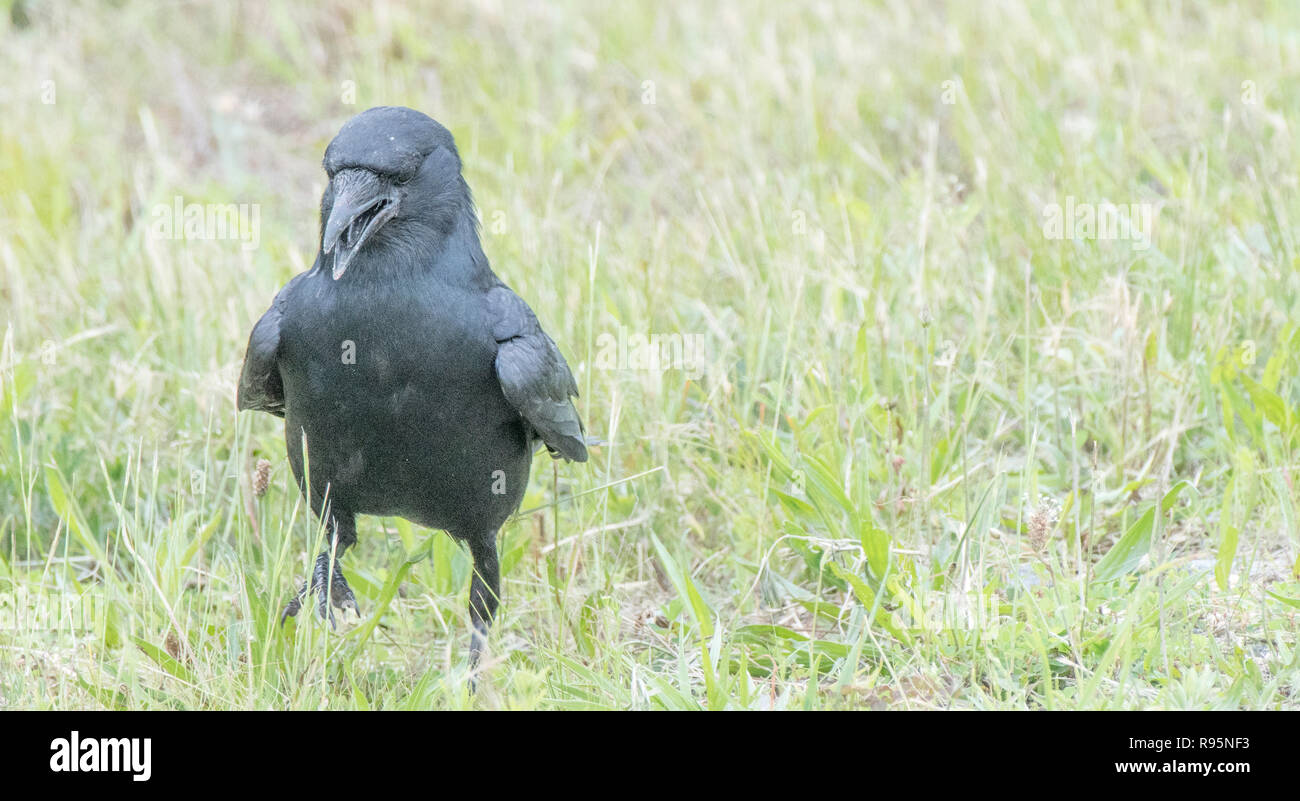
[488,286,586,462]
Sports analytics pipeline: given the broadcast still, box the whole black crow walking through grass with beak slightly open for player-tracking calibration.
[238,107,586,664]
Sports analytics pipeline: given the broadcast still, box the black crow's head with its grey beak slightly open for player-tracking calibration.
[321,105,472,281]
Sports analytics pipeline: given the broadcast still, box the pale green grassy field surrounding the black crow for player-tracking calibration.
[0,0,1300,709]
